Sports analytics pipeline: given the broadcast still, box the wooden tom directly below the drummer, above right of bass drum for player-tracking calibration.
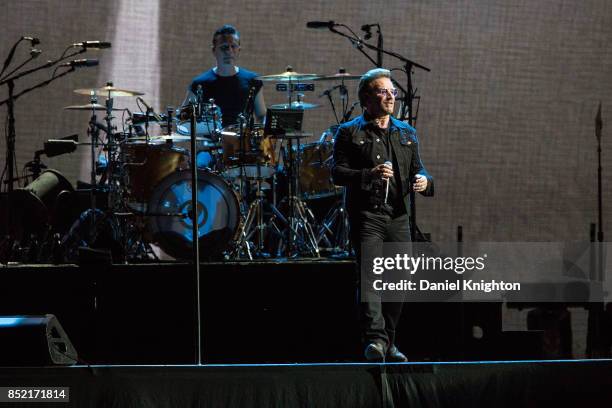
[221,125,276,178]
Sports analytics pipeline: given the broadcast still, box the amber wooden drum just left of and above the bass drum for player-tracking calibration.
[122,140,189,203]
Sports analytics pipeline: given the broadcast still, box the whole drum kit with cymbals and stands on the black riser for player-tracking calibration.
[7,67,359,262]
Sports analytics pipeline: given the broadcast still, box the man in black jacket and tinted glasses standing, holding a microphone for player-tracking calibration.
[332,68,434,362]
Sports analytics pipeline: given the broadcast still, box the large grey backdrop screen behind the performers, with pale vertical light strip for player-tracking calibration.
[0,0,612,241]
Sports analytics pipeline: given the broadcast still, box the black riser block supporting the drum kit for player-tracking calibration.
[0,263,360,364]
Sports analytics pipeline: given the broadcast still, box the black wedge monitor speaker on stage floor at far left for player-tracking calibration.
[0,314,78,367]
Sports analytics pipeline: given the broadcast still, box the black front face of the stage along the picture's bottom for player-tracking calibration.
[0,360,612,408]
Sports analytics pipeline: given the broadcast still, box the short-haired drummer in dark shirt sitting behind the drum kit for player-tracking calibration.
[184,24,266,127]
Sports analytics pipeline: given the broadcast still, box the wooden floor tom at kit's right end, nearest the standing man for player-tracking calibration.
[300,142,342,200]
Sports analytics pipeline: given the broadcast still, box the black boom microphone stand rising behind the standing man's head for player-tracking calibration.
[329,24,431,242]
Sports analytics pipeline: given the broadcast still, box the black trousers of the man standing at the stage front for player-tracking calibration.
[351,211,410,348]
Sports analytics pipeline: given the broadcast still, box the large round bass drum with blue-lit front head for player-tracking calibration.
[148,170,240,259]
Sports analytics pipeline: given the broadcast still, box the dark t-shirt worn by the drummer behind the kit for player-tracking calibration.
[189,68,263,127]
